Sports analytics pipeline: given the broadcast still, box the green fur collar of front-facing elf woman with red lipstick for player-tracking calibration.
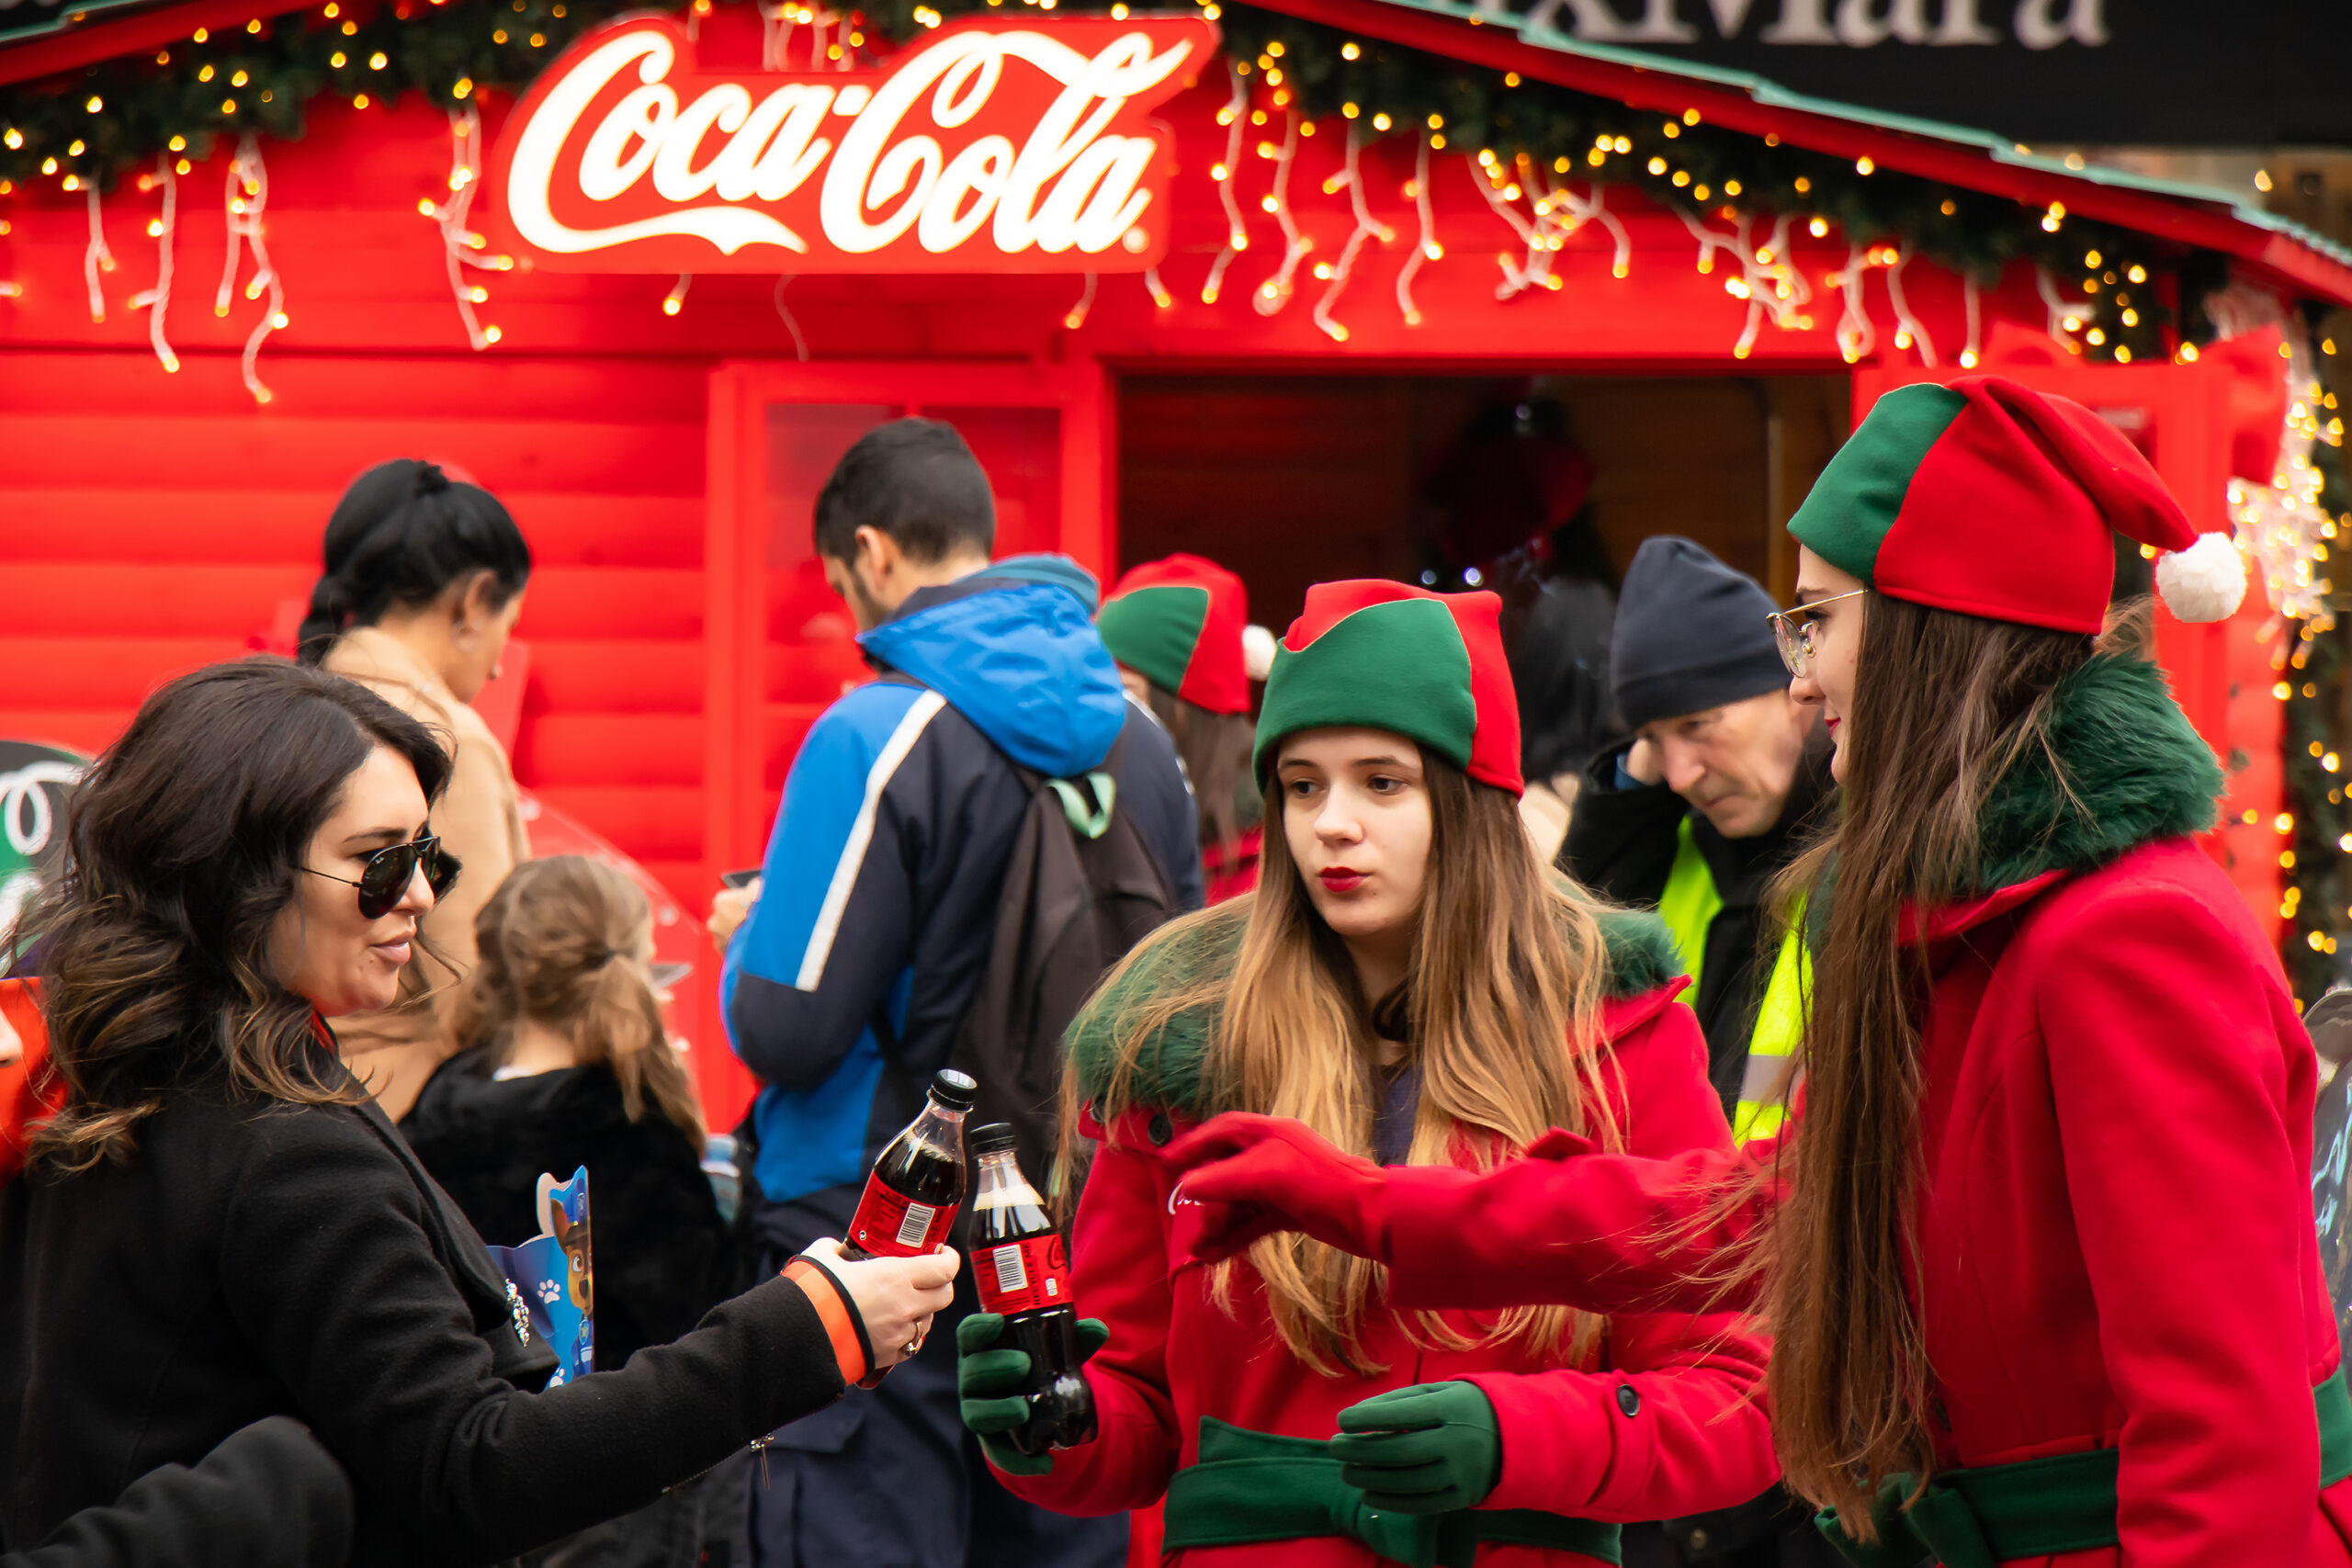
[1063,898,1681,1114]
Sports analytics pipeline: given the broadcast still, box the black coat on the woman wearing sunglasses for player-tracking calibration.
[0,1072,842,1568]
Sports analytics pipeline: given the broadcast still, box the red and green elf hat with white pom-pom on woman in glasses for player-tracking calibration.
[1788,376,2246,632]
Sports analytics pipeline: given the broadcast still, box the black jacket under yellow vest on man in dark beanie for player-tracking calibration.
[1559,724,1835,1117]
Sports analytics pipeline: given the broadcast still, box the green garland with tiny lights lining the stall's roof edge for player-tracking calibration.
[0,0,2225,360]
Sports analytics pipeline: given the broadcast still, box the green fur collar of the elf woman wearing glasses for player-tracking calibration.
[1962,659,2222,894]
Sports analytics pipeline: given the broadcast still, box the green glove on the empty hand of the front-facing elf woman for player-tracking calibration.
[1331,1382,1503,1514]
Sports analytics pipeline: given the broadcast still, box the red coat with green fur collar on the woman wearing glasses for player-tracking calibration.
[1176,660,2352,1568]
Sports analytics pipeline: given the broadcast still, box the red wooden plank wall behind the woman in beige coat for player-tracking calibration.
[0,350,708,987]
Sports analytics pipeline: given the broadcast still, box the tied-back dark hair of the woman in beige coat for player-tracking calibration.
[299,458,532,665]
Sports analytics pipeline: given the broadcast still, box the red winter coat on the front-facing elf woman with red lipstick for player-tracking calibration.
[1002,917,1778,1568]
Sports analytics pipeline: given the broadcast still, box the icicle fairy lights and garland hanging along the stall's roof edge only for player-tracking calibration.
[0,0,2225,389]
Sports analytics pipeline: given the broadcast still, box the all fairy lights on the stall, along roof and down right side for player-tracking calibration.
[0,0,2352,997]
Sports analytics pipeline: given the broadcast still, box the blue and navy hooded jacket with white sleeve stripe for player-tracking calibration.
[719,558,1202,1215]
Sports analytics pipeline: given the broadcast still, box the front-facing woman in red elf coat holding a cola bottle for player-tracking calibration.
[957,583,1773,1568]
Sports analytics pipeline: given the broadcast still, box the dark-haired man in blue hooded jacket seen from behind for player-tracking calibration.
[713,419,1202,1568]
